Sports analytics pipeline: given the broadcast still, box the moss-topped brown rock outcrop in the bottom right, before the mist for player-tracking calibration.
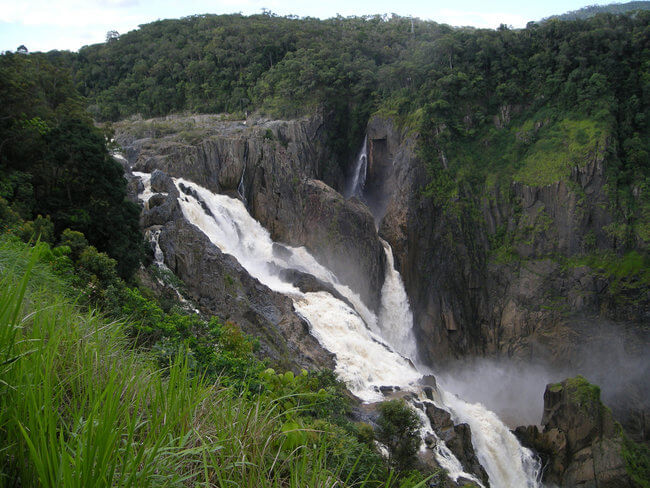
[515,376,636,488]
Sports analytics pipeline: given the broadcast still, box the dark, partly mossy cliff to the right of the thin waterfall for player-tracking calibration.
[366,117,650,440]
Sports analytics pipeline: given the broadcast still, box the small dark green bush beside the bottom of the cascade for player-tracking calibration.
[376,400,422,471]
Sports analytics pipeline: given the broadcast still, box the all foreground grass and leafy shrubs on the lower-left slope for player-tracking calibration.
[0,236,436,487]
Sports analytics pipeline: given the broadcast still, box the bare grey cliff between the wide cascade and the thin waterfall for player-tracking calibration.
[116,116,385,310]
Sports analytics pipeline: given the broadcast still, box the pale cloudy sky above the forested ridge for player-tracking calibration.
[0,0,611,52]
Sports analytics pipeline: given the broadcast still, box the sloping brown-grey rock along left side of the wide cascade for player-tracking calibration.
[135,170,334,369]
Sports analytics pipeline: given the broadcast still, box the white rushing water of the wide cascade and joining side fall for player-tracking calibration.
[137,173,540,488]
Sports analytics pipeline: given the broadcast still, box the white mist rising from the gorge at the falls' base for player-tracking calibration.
[436,322,650,432]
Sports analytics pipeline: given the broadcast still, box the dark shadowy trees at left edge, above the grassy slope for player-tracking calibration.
[0,54,142,278]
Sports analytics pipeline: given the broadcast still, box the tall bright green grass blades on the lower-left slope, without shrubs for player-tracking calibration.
[0,240,380,488]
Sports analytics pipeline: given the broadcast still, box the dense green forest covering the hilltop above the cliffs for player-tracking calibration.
[21,7,650,262]
